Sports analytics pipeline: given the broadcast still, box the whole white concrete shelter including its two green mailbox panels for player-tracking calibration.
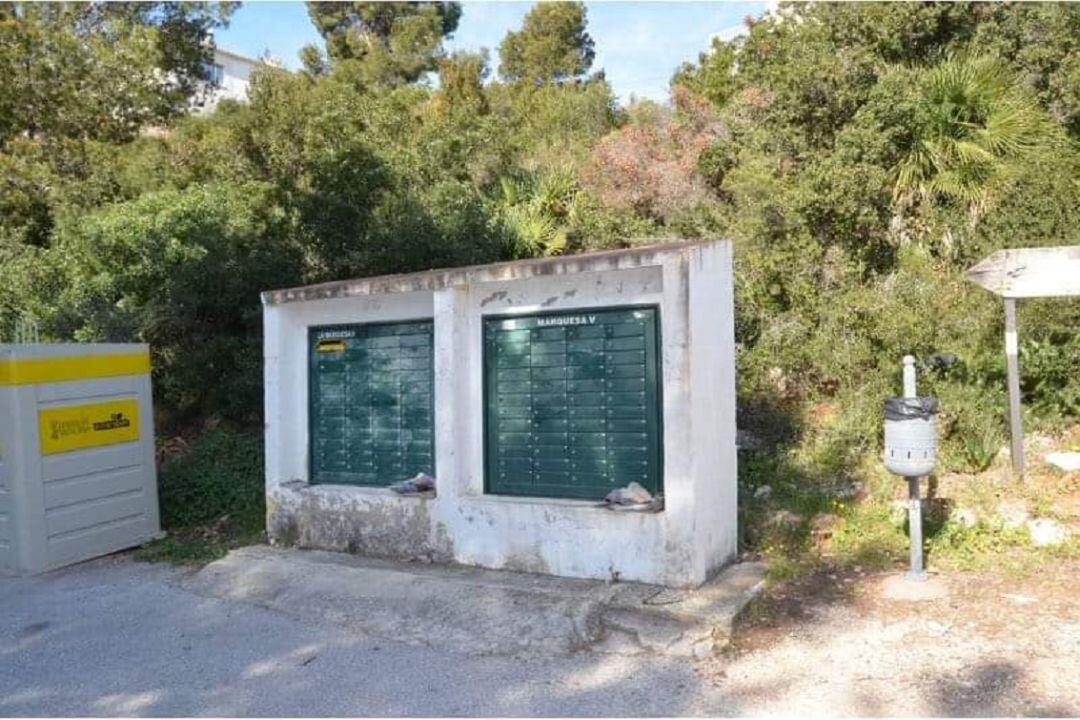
[262,241,738,586]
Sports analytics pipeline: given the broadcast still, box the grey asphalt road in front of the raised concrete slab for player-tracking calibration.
[0,557,734,716]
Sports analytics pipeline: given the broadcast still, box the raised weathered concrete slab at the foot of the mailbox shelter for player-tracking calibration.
[185,546,762,656]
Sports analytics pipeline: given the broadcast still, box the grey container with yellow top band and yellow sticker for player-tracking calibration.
[0,344,160,574]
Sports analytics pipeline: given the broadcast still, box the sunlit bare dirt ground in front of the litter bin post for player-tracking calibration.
[698,560,1080,717]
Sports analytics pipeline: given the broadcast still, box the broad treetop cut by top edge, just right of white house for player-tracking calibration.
[305,2,461,85]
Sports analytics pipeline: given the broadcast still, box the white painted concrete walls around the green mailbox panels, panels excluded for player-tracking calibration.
[264,241,737,586]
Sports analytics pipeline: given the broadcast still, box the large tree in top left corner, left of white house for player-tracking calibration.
[0,2,237,149]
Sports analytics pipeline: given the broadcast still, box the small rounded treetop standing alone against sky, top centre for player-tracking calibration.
[499,2,596,85]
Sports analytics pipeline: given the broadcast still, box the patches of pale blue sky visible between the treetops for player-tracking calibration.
[217,2,766,101]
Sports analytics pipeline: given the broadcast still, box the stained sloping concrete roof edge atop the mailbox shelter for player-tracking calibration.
[261,240,730,305]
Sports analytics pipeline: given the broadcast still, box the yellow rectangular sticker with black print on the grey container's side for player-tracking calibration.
[38,399,138,454]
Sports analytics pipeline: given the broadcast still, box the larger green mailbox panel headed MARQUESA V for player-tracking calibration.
[484,307,662,499]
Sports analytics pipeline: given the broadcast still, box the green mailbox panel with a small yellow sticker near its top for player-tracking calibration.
[309,321,435,486]
